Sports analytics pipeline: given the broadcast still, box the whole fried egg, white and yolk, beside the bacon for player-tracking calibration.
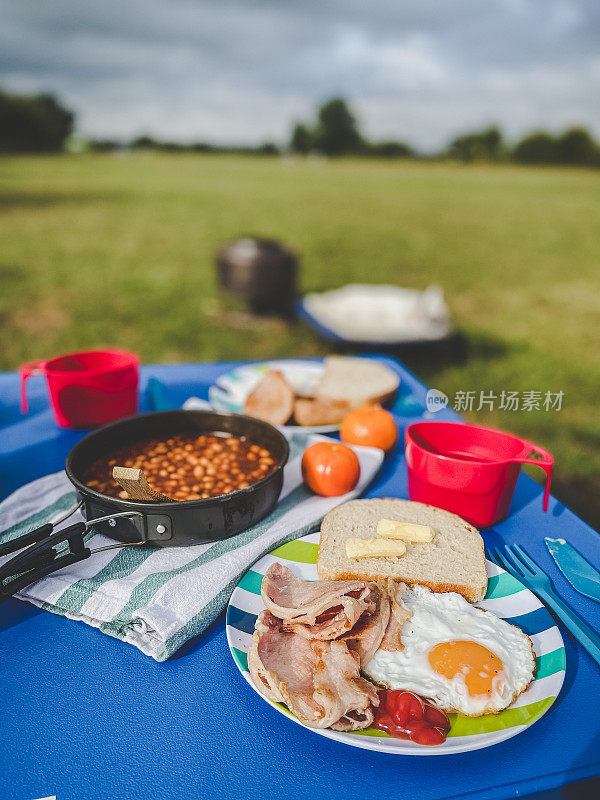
[363,586,535,716]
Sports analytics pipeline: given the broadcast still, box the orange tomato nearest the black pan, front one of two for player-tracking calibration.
[302,442,360,497]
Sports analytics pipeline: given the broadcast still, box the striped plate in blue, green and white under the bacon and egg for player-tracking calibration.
[227,533,565,756]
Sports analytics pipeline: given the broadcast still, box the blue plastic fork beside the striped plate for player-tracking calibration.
[488,544,600,664]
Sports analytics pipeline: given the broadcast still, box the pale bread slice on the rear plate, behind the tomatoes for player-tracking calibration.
[315,356,400,407]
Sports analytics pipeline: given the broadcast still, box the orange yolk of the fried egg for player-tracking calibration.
[429,641,504,696]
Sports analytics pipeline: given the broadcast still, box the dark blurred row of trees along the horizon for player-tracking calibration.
[0,91,600,166]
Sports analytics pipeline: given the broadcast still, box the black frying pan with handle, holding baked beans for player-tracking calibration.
[0,411,289,603]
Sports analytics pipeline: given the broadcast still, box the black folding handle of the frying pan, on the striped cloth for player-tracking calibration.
[0,522,91,603]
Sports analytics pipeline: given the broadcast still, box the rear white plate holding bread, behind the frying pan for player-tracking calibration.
[208,359,340,433]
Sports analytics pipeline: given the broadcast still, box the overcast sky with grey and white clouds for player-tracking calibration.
[0,0,600,150]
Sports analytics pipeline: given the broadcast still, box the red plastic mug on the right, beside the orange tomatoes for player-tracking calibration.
[405,422,554,528]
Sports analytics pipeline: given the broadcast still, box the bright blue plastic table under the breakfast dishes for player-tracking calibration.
[0,362,600,800]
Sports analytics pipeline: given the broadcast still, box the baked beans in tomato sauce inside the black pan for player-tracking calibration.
[83,432,277,501]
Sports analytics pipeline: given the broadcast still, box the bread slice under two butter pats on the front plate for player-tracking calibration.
[317,499,487,603]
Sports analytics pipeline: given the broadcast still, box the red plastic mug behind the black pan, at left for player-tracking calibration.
[20,350,140,428]
